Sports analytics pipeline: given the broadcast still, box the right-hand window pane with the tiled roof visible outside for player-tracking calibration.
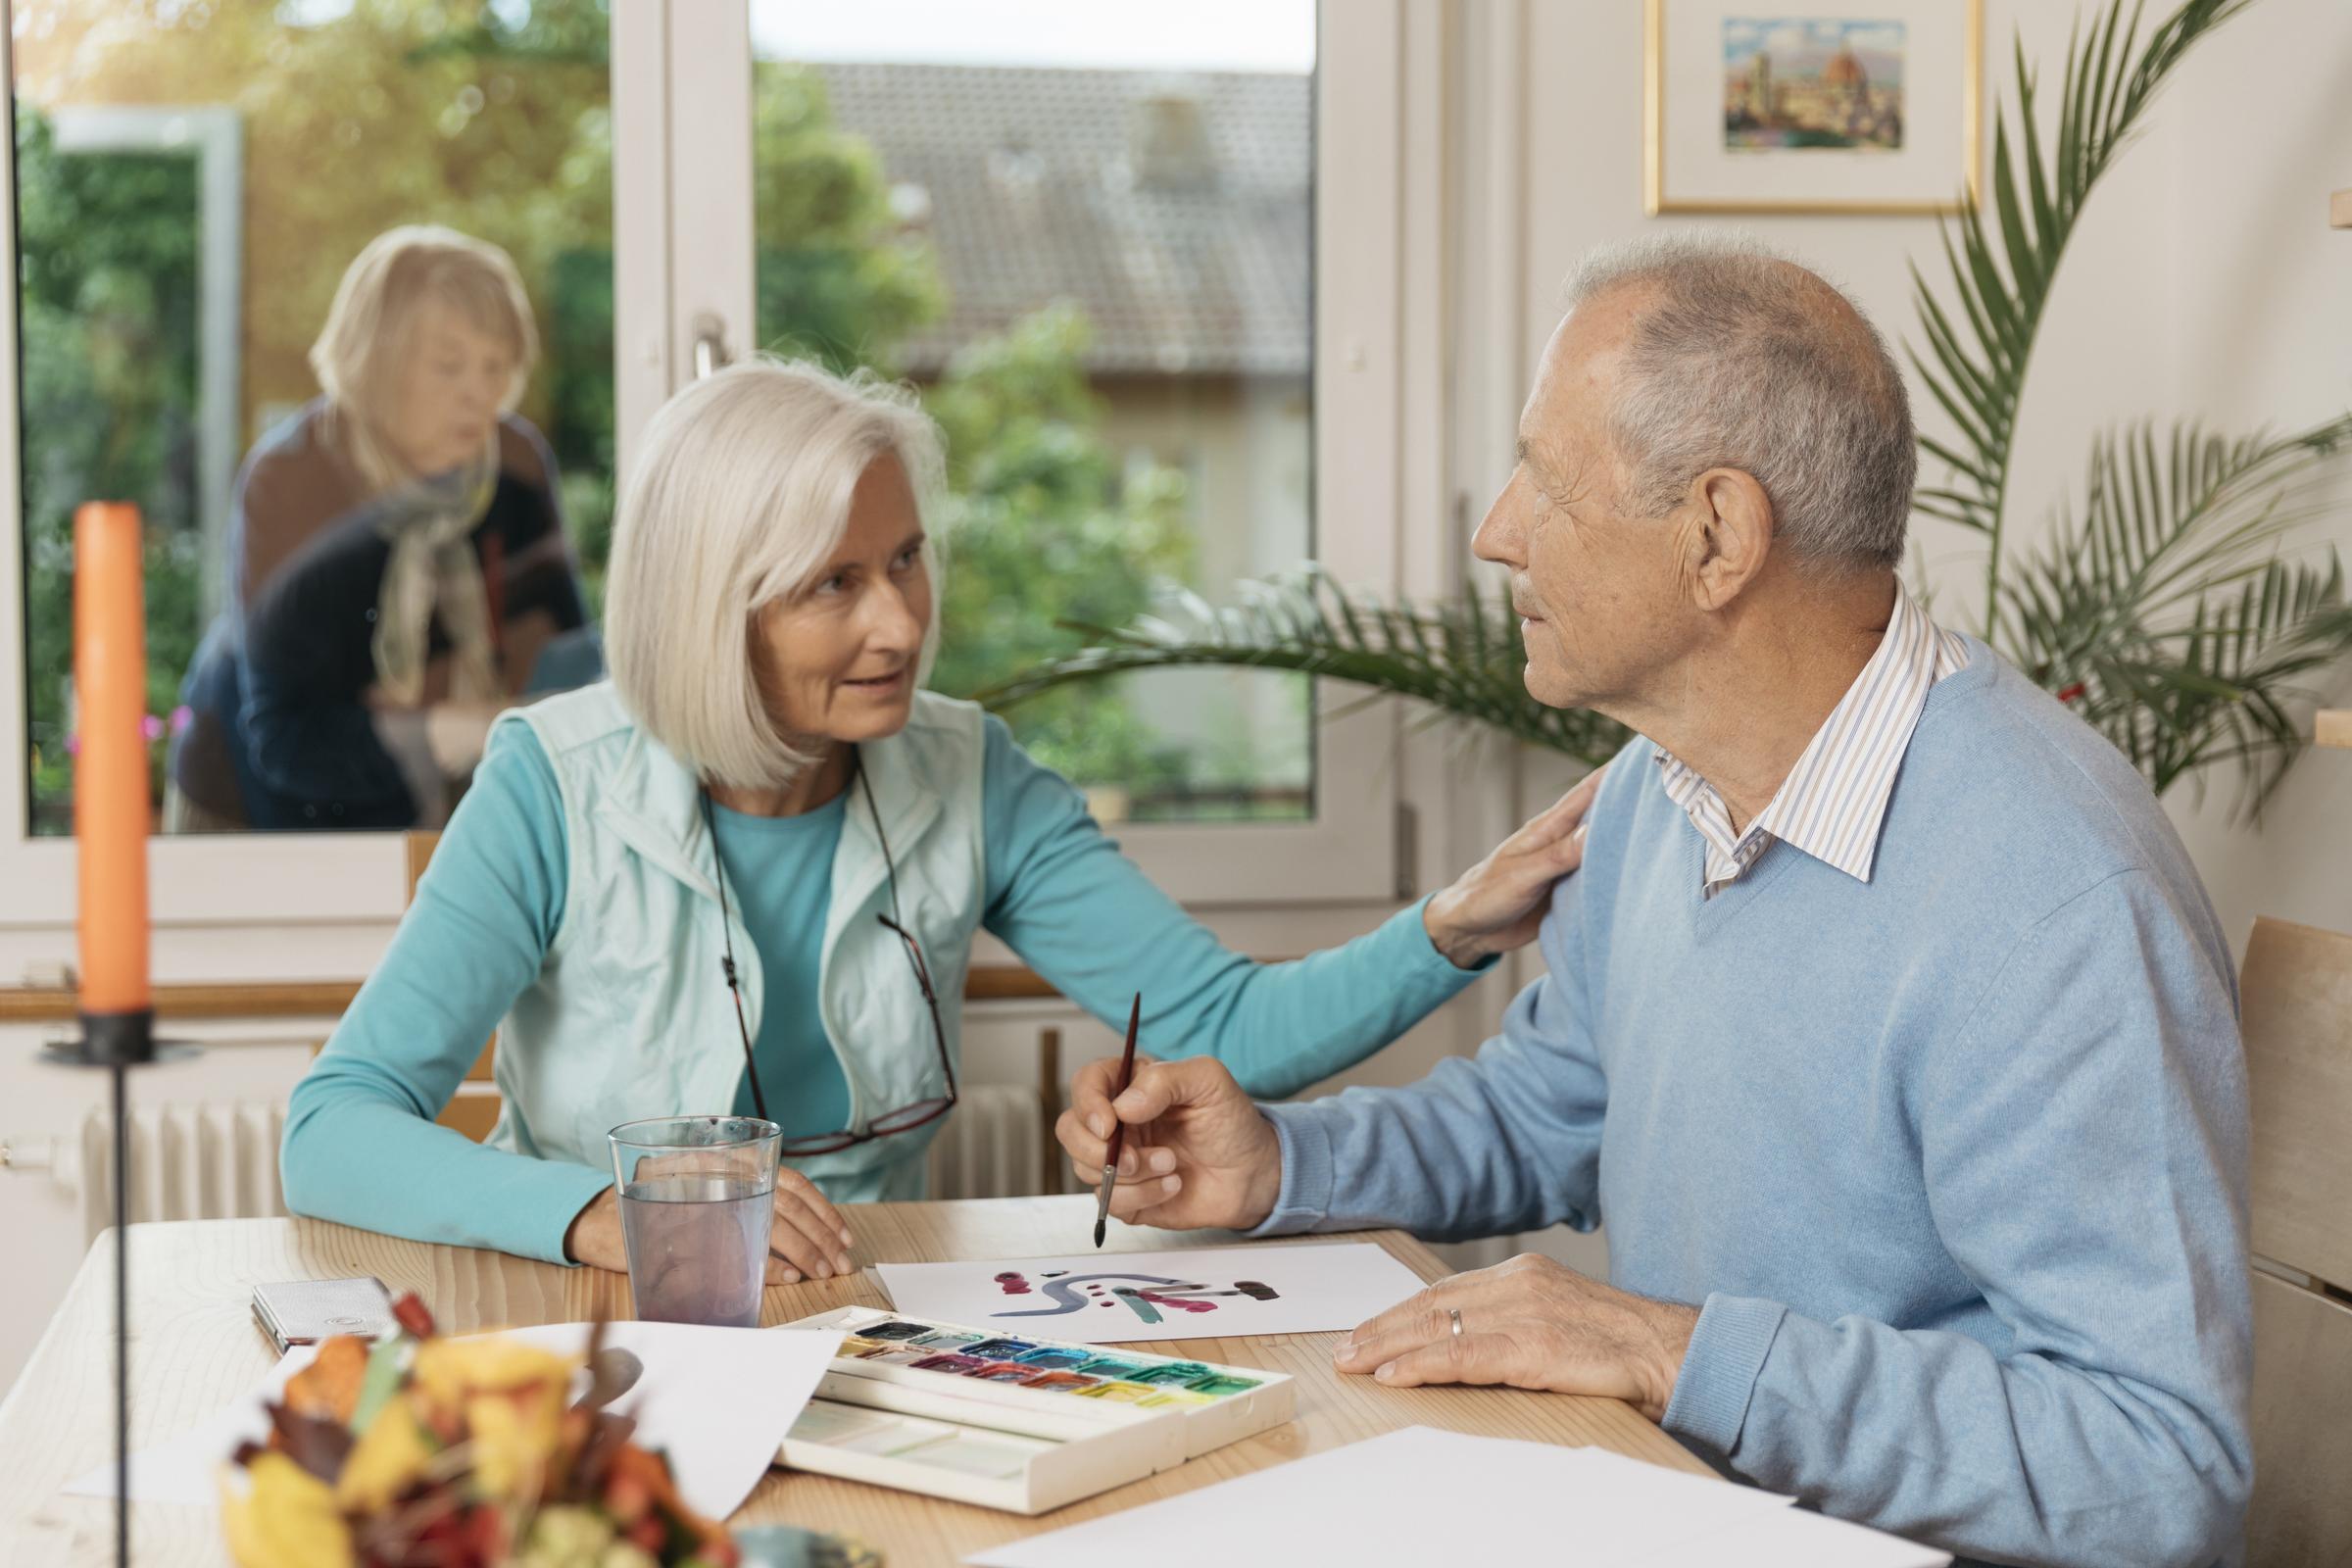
[751,0,1315,820]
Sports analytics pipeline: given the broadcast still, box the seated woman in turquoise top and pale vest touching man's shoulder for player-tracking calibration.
[282,362,1583,1281]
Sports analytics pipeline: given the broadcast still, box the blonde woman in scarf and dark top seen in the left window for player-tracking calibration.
[167,228,583,832]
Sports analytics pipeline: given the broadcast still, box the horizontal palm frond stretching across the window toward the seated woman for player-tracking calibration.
[978,566,1628,766]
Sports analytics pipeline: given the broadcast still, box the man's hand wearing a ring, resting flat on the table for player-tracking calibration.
[1336,1253,1698,1420]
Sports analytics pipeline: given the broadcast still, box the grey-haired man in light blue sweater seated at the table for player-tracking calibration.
[1060,240,2251,1568]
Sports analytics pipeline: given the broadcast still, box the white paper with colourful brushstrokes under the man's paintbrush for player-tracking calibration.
[875,1242,1423,1345]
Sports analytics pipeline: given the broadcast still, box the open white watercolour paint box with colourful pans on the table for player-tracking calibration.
[778,1307,1294,1514]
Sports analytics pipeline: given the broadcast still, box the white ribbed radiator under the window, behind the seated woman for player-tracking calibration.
[52,1084,1060,1244]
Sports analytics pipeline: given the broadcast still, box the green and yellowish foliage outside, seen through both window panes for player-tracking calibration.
[17,0,1218,832]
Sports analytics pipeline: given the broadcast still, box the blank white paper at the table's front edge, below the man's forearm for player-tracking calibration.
[964,1427,1950,1568]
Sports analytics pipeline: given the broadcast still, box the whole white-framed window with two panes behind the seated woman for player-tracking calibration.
[0,0,1401,950]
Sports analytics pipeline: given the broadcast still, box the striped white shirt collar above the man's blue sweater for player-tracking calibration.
[1656,583,1969,898]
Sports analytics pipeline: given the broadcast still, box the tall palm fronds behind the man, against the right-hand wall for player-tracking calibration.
[1912,0,2352,808]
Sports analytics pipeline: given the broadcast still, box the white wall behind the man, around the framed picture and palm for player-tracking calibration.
[1463,0,2352,1267]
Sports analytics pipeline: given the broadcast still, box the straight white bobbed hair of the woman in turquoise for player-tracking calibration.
[605,358,943,790]
